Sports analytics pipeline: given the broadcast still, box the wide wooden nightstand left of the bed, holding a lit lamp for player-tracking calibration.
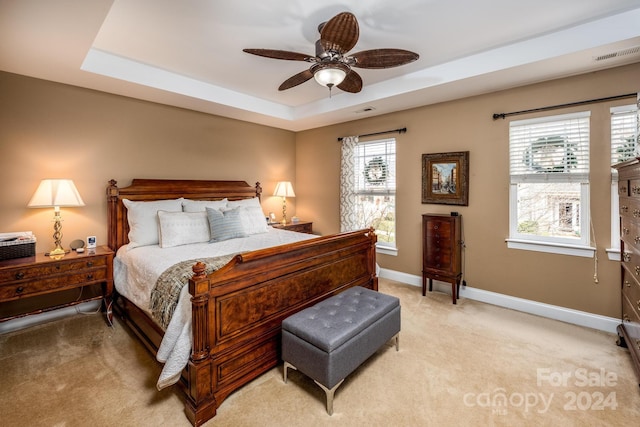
[0,246,114,325]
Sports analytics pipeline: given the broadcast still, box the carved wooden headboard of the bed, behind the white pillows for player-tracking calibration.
[107,179,262,251]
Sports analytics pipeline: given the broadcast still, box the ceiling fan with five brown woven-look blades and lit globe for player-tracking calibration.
[243,12,419,93]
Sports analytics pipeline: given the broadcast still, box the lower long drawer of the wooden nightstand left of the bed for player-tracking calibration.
[0,268,107,301]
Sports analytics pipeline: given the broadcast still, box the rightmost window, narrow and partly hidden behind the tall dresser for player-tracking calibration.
[609,105,638,260]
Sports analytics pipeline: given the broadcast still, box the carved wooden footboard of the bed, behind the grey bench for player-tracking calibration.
[186,230,378,425]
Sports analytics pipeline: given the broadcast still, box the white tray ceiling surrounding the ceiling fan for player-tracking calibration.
[0,0,640,131]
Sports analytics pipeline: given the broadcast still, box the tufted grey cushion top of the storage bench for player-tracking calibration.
[282,286,400,353]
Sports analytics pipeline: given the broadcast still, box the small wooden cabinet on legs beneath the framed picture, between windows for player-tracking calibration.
[422,214,462,304]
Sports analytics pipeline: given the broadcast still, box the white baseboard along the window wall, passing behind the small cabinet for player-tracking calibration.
[378,268,620,334]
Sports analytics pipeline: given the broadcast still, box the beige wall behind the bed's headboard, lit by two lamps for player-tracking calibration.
[0,73,295,252]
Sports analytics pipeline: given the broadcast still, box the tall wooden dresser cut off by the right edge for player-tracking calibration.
[614,159,640,382]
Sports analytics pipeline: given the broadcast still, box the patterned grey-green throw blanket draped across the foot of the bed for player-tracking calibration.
[150,254,235,330]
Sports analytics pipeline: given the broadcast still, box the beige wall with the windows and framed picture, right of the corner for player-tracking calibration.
[296,64,640,317]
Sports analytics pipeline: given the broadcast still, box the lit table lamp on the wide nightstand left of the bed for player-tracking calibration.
[27,179,84,257]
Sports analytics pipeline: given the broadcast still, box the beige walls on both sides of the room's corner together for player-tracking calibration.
[0,64,640,317]
